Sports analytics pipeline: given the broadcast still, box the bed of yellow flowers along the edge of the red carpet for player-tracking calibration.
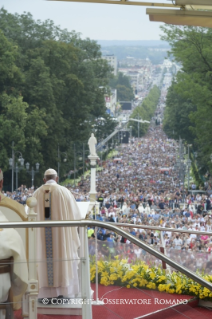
[90,256,212,301]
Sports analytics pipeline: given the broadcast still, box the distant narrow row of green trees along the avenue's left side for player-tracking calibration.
[128,86,160,137]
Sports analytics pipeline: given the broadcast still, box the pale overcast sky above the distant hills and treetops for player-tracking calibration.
[0,0,165,40]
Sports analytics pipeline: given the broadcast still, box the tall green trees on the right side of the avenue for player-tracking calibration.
[162,26,212,173]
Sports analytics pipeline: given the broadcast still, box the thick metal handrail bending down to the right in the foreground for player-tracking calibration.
[0,220,212,291]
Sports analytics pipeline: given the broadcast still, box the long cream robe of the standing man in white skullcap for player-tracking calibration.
[33,180,81,298]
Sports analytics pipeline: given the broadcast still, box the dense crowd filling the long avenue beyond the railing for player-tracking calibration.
[2,109,212,276]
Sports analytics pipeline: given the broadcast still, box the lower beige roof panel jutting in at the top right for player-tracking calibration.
[146,9,212,28]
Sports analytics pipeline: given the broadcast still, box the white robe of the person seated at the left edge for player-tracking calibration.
[0,211,28,318]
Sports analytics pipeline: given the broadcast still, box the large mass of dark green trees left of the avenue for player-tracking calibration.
[0,8,114,188]
